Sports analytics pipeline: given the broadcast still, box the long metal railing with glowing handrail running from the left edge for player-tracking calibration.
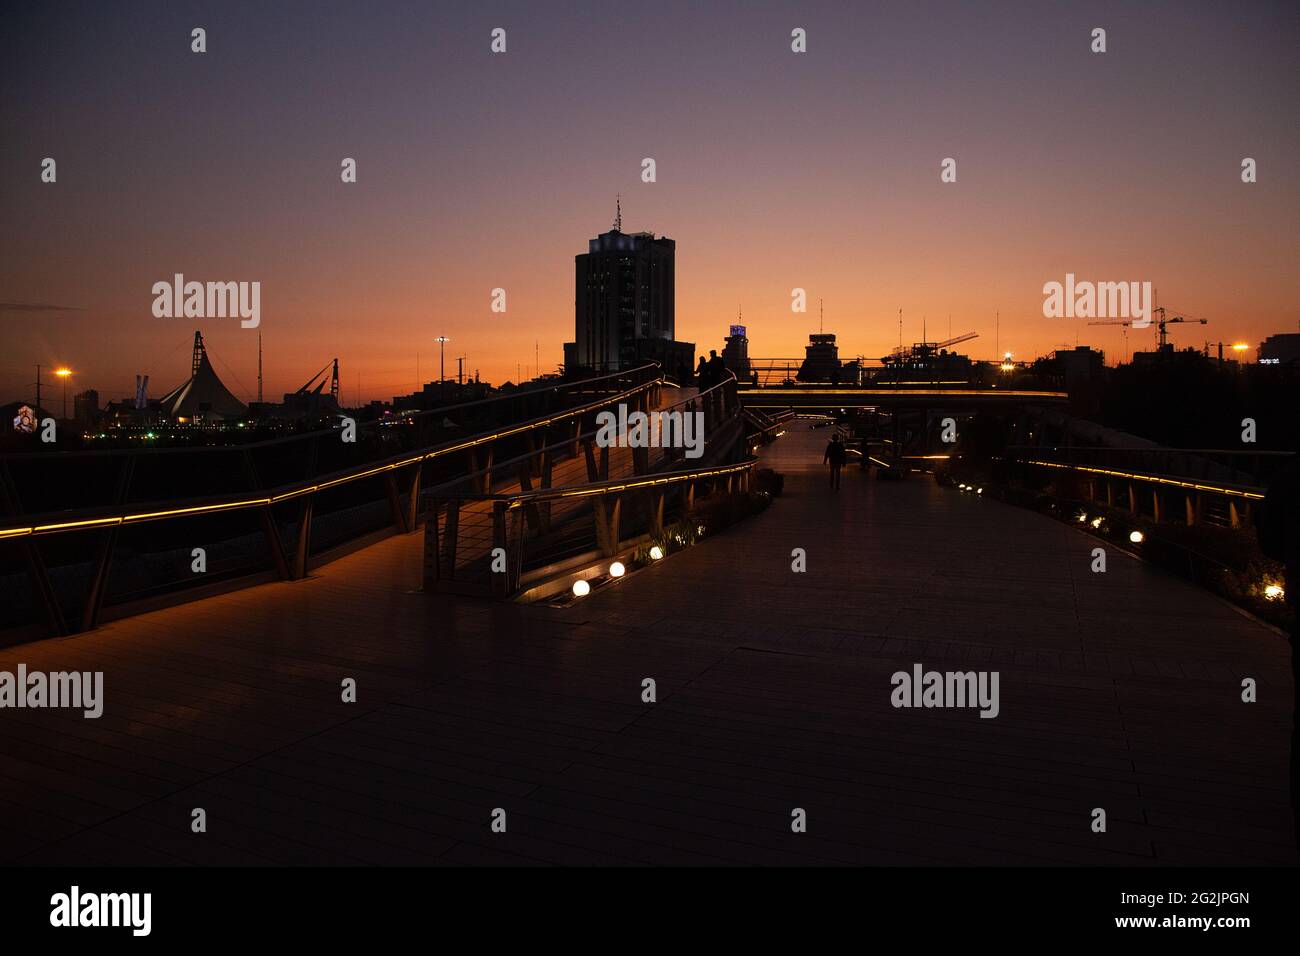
[0,364,662,635]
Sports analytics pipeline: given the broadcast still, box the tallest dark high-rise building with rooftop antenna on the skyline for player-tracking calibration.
[564,211,694,372]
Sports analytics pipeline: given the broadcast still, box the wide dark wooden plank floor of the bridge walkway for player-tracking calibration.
[0,421,1295,865]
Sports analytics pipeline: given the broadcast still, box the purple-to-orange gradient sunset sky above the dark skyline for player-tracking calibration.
[0,0,1300,402]
